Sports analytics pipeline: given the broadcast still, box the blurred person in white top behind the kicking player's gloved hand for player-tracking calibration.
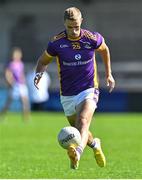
[27,69,50,111]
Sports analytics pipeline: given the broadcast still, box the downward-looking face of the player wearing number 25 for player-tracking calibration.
[64,18,82,39]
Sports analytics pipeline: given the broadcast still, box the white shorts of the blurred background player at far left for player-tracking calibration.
[10,83,28,100]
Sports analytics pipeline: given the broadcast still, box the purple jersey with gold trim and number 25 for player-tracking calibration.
[47,29,103,96]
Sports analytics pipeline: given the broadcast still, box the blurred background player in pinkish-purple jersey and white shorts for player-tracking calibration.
[0,47,30,121]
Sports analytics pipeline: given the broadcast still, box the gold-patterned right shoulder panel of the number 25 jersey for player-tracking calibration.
[82,29,99,41]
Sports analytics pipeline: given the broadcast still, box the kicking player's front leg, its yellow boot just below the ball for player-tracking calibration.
[67,100,94,169]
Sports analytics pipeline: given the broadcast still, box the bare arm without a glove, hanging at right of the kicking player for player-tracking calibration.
[97,40,115,92]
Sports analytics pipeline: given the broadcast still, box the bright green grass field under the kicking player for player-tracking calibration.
[0,113,142,179]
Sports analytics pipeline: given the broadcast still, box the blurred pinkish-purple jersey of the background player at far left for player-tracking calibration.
[8,61,25,84]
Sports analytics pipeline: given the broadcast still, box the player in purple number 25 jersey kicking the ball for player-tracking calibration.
[34,7,115,169]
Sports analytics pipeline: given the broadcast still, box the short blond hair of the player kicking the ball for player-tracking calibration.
[64,7,82,21]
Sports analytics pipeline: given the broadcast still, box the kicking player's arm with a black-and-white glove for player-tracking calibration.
[34,51,52,89]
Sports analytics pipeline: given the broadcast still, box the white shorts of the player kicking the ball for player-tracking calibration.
[60,88,99,116]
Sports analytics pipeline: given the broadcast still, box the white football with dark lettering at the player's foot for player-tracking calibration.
[58,126,81,149]
